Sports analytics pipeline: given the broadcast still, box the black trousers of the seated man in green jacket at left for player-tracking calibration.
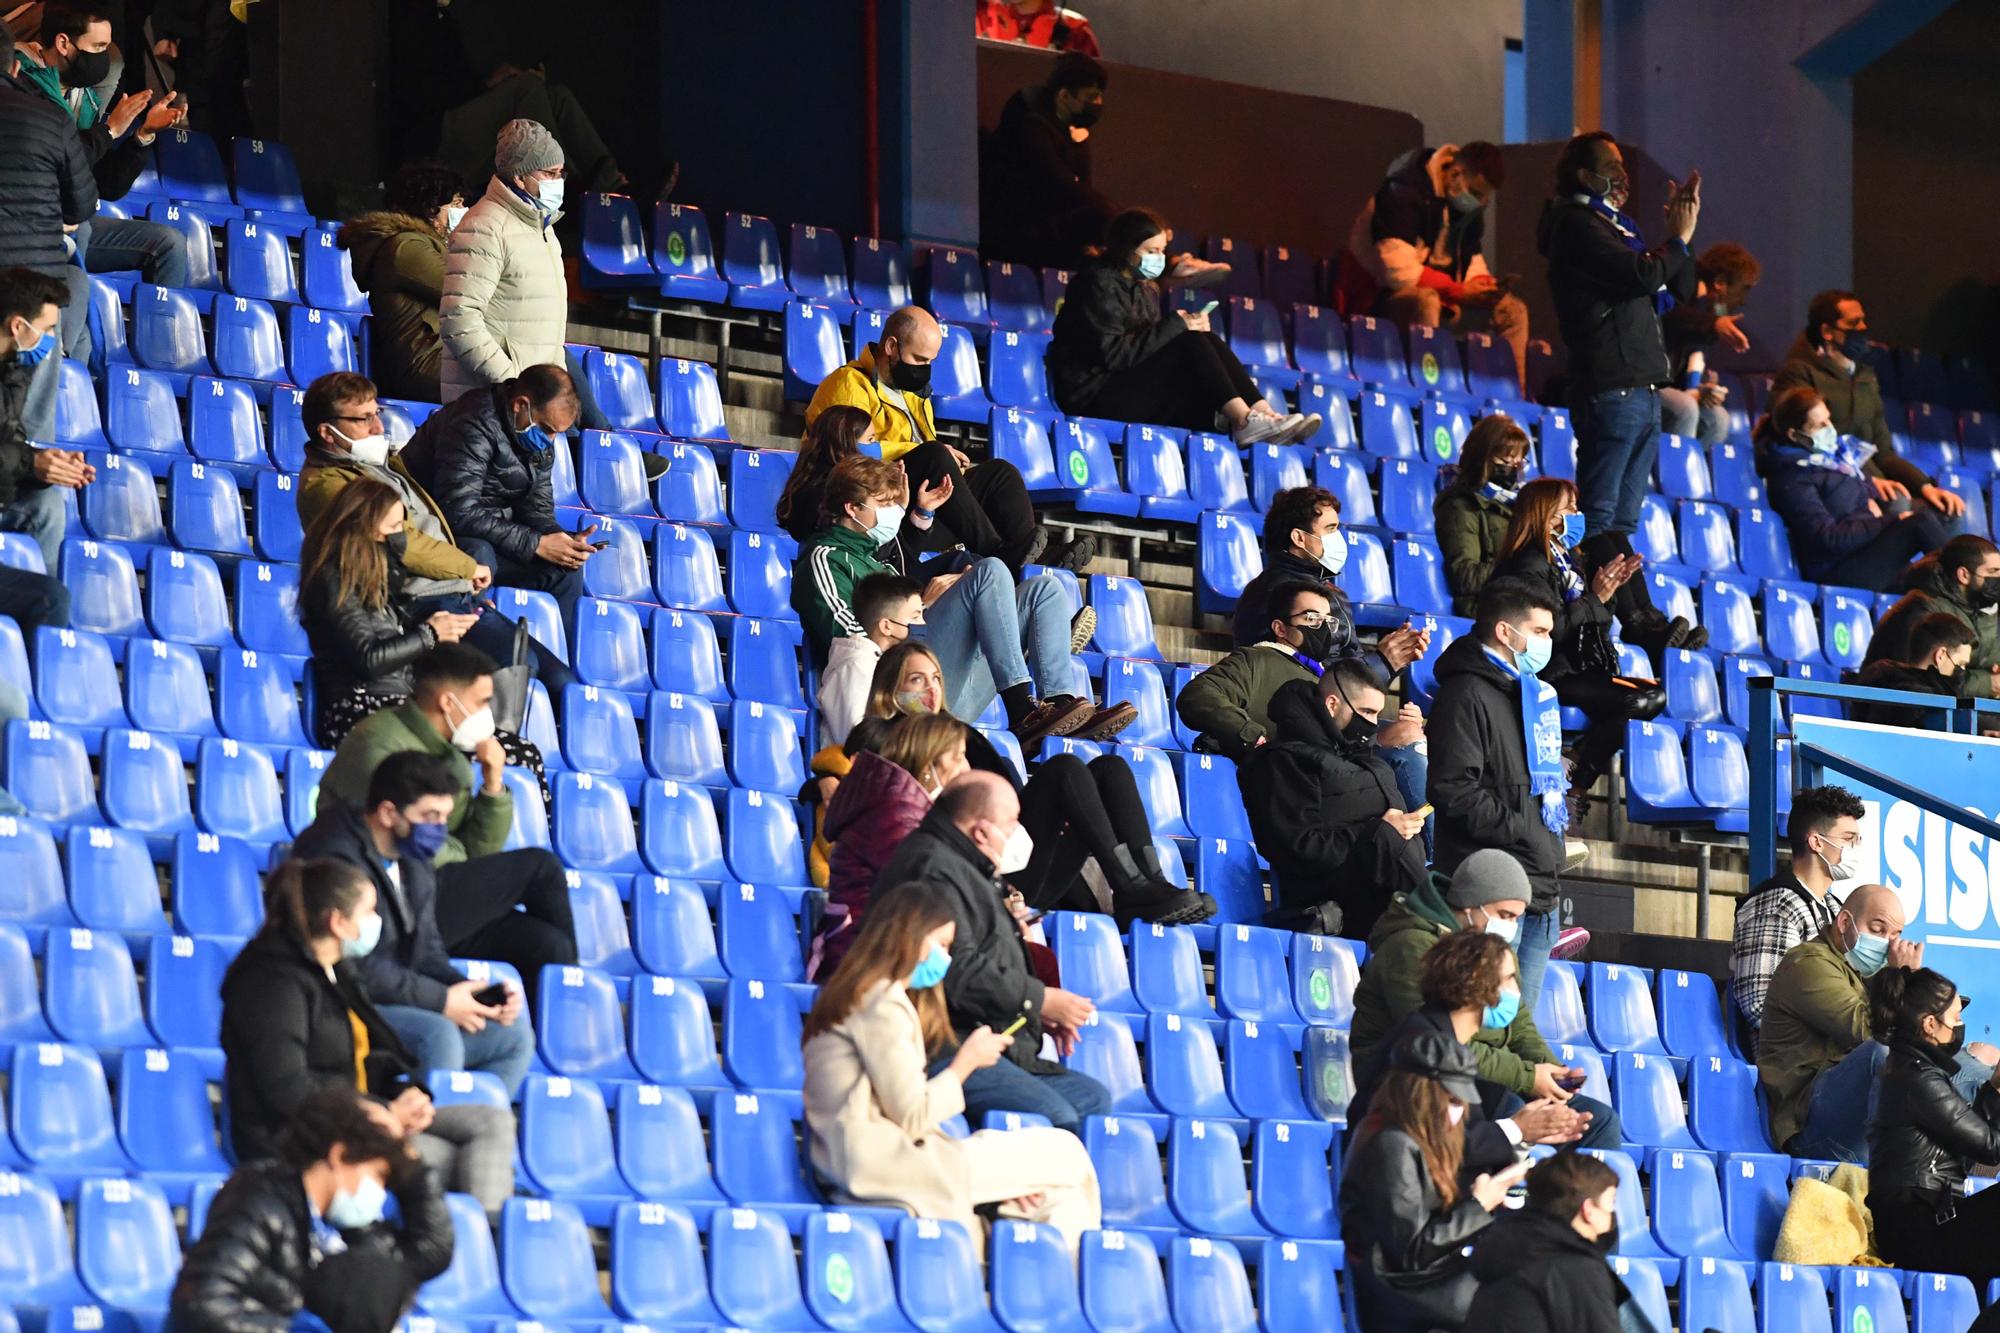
[438,847,576,1000]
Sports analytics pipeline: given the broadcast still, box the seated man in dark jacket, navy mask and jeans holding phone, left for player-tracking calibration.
[292,751,534,1097]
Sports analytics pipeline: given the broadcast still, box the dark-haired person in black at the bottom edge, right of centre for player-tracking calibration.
[1466,1153,1632,1333]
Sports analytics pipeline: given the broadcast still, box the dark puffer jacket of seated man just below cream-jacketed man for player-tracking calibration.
[400,386,568,564]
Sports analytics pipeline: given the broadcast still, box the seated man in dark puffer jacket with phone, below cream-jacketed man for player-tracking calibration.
[402,364,598,636]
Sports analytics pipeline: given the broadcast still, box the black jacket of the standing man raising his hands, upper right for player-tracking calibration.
[1536,196,1696,402]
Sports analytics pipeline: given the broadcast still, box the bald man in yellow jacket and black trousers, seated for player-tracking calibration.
[806,306,1096,578]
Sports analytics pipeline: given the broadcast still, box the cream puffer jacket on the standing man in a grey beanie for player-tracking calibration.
[438,176,570,402]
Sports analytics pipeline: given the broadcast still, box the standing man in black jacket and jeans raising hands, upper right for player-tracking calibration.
[1538,130,1702,588]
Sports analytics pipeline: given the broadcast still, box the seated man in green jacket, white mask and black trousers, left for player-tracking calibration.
[314,644,576,1011]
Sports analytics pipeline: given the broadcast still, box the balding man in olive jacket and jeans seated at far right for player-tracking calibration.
[1756,885,2000,1165]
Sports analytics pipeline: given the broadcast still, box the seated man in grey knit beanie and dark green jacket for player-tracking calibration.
[1350,851,1624,1149]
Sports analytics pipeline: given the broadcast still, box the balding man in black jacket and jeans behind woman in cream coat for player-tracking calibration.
[876,771,1112,1133]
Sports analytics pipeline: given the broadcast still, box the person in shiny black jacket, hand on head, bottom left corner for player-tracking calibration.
[168,1071,454,1333]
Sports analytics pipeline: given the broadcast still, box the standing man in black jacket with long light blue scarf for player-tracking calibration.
[1430,578,1570,1015]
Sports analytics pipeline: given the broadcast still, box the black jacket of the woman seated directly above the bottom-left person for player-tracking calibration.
[222,931,420,1161]
